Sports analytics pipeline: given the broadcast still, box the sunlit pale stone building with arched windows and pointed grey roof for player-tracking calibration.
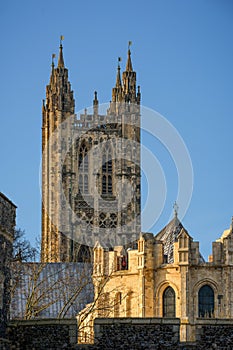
[78,213,233,342]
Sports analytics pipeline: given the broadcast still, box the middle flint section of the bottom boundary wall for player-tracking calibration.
[76,318,180,350]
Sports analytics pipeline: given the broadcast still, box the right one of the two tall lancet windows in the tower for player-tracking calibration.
[102,146,113,195]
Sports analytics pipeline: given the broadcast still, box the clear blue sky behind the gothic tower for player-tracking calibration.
[0,0,233,256]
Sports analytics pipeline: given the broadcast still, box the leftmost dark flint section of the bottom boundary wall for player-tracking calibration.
[8,319,77,350]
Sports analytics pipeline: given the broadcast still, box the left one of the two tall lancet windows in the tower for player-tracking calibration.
[78,144,88,193]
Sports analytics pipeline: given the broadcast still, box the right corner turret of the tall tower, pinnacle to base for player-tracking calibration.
[108,45,141,245]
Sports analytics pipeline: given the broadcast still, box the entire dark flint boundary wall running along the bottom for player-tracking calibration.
[0,318,233,350]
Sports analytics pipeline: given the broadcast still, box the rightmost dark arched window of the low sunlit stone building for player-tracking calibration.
[198,284,214,317]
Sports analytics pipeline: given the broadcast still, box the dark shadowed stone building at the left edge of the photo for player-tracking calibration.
[0,193,16,337]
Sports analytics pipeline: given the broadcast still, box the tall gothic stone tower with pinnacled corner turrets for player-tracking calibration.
[41,45,141,262]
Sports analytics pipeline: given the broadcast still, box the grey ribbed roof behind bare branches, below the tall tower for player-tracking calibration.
[11,247,93,319]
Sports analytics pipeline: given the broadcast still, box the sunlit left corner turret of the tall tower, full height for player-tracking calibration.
[41,44,75,262]
